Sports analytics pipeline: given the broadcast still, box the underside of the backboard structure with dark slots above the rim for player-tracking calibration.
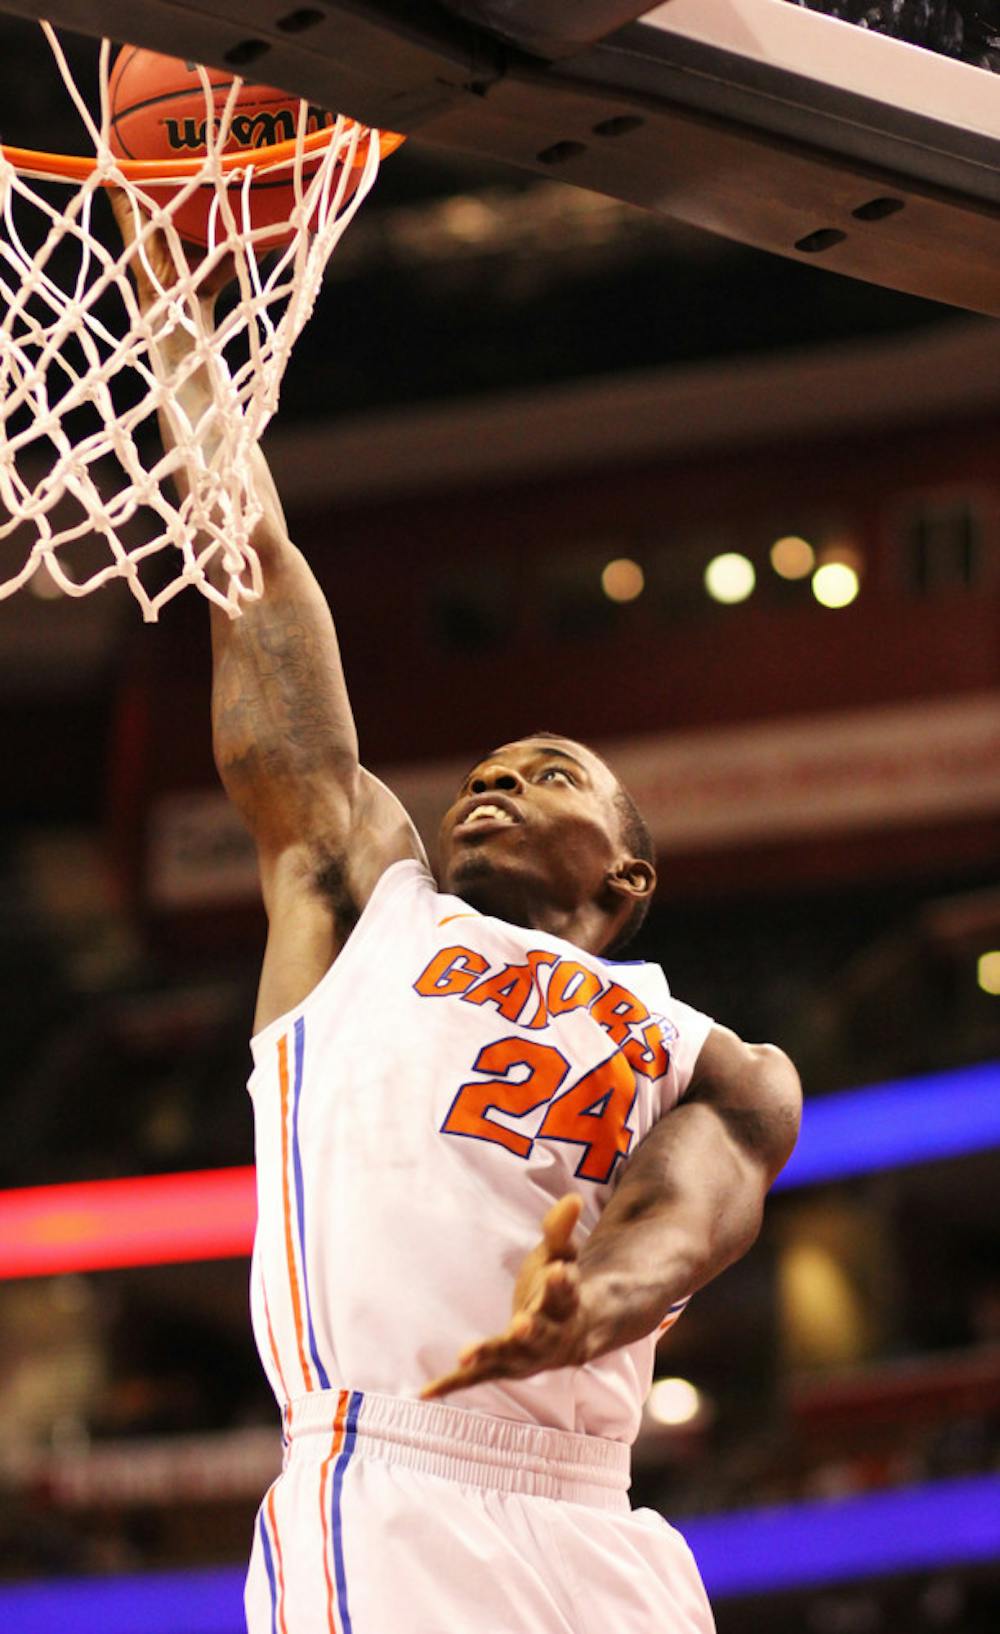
[2,0,1000,315]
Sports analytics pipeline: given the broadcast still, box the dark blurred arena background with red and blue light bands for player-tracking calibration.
[0,8,1000,1634]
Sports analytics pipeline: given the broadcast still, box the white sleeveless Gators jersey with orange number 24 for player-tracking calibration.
[250,861,712,1441]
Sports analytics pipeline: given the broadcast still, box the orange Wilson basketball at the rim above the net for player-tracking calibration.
[108,46,343,248]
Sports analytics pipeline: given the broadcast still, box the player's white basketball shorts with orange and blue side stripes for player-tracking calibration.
[245,1391,714,1634]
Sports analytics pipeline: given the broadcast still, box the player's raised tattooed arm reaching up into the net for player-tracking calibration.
[114,198,423,1028]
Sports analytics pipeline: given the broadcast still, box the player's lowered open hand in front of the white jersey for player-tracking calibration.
[420,1193,588,1400]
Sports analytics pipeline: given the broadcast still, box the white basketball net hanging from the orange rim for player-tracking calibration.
[0,23,402,619]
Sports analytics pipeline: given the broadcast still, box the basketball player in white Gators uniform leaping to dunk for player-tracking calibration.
[111,197,799,1634]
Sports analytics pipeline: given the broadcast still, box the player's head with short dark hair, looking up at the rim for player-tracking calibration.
[440,737,627,926]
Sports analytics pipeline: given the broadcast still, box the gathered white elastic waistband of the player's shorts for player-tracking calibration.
[283,1389,631,1510]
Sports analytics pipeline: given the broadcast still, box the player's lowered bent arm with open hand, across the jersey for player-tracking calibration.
[423,1026,802,1397]
